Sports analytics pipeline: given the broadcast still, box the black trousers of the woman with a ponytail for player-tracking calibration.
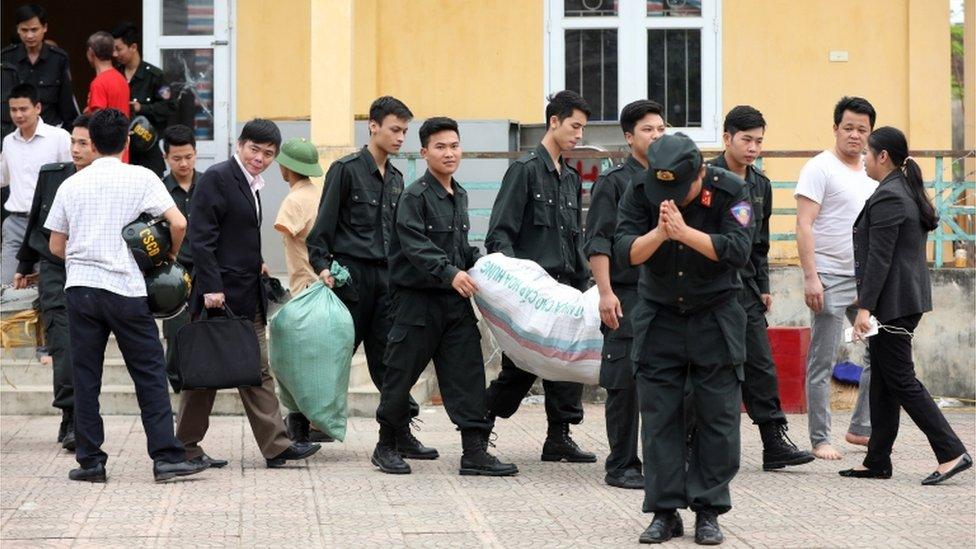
[864,314,966,470]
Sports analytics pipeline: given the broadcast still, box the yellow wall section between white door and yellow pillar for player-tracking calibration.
[235,0,311,121]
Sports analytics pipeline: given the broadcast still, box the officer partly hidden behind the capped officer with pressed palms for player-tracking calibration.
[583,99,665,490]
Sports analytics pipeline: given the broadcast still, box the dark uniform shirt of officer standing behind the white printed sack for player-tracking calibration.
[485,143,588,287]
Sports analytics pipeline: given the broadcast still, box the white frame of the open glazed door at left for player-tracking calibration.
[142,0,236,167]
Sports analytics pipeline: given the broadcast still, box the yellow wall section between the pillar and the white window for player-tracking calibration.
[353,0,544,123]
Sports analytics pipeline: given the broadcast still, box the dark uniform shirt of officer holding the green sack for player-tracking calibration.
[306,147,403,273]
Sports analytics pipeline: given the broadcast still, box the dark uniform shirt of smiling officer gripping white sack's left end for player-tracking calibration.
[390,172,481,291]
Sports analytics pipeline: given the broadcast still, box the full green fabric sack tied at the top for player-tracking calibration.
[268,275,354,441]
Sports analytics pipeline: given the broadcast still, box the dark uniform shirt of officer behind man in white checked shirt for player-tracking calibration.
[17,162,75,274]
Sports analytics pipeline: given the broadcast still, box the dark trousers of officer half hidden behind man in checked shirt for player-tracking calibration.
[38,261,75,414]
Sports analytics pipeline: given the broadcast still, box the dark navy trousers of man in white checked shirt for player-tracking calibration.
[66,287,186,467]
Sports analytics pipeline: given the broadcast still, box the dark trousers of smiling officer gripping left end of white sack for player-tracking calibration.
[376,290,489,431]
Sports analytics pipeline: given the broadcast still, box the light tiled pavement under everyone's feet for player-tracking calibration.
[0,405,976,548]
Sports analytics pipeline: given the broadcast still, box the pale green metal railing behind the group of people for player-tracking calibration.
[397,150,976,267]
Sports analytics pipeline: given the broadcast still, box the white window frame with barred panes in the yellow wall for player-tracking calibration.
[543,0,722,146]
